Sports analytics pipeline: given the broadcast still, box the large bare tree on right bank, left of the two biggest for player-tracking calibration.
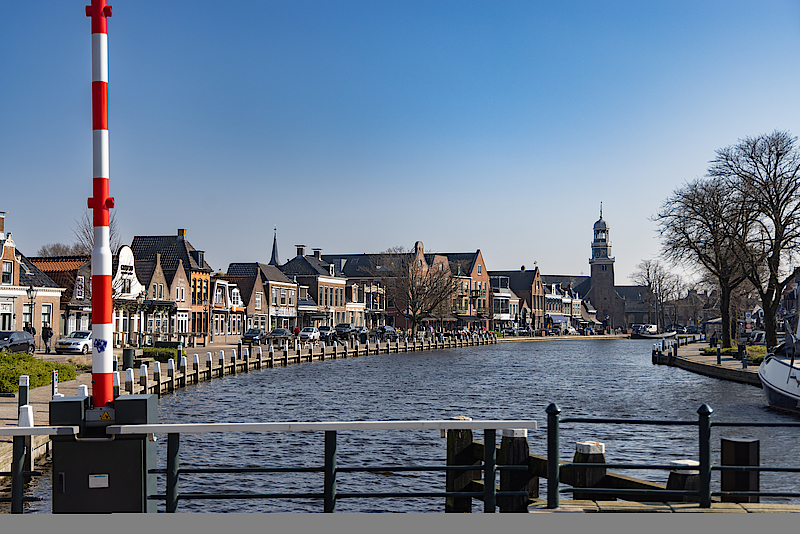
[654,178,750,347]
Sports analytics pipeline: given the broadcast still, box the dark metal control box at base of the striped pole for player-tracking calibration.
[50,395,158,514]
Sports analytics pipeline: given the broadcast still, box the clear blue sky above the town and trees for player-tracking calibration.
[0,0,800,284]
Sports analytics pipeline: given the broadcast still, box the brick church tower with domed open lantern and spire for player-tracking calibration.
[586,204,624,328]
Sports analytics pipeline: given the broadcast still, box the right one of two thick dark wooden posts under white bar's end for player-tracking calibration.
[497,428,539,512]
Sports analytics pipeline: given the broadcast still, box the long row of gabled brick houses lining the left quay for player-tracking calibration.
[0,212,636,346]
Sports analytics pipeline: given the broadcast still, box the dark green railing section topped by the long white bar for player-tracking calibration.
[106,420,536,513]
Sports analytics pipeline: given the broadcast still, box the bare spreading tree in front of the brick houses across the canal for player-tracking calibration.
[372,246,455,333]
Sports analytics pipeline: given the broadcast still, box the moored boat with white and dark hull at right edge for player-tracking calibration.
[758,323,800,414]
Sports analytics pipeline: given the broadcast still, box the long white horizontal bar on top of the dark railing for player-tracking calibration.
[106,419,537,434]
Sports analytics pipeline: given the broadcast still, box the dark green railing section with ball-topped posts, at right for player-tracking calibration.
[545,404,800,508]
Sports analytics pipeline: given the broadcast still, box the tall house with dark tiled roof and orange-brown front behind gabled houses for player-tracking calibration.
[131,229,212,343]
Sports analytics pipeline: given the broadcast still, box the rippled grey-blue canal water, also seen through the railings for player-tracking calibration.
[6,339,800,512]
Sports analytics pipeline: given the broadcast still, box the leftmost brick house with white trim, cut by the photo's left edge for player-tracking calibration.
[0,211,64,345]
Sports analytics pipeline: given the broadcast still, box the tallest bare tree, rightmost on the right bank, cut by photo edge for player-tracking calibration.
[708,130,800,346]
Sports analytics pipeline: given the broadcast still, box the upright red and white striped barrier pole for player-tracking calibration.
[86,0,114,407]
